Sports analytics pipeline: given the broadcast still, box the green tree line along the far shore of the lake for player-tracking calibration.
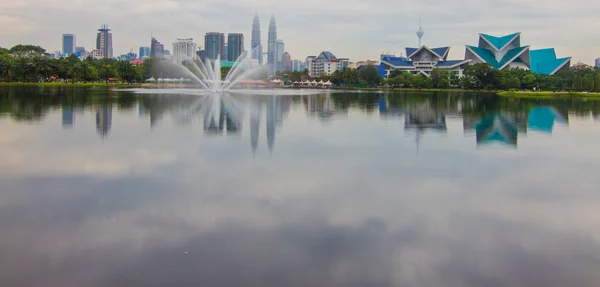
[0,45,600,91]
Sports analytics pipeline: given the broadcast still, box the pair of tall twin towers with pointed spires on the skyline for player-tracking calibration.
[251,14,277,71]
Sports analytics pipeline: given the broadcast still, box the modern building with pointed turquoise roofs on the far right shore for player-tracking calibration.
[465,32,571,75]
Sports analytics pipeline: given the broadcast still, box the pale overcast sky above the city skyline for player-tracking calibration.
[0,0,600,65]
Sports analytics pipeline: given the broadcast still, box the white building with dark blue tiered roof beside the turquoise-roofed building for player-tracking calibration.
[380,45,470,77]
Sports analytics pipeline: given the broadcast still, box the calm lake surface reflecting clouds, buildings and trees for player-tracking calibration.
[0,87,600,287]
